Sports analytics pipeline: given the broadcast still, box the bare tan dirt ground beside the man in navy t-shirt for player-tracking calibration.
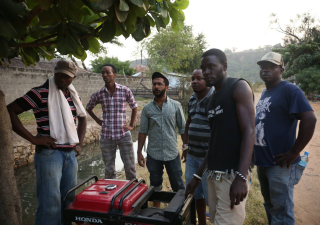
[255,93,320,225]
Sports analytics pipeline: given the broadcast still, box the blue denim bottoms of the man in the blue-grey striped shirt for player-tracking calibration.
[184,155,208,201]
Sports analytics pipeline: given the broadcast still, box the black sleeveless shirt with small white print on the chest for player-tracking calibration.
[207,77,251,172]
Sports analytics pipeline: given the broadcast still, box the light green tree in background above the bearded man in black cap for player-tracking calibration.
[143,26,206,73]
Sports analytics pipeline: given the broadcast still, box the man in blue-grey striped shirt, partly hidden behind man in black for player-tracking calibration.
[181,69,214,225]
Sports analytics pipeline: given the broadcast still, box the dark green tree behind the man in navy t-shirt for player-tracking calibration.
[273,13,320,94]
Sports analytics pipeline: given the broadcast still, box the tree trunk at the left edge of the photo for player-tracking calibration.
[0,90,22,225]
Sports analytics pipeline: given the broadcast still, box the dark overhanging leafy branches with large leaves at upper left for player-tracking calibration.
[0,0,189,66]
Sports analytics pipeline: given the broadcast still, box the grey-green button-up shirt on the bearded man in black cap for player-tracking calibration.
[139,97,185,161]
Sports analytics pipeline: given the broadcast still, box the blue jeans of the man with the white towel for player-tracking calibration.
[34,149,78,225]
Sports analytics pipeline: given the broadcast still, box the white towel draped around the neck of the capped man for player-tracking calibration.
[48,76,87,145]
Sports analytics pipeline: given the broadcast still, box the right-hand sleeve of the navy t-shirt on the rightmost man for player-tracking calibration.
[289,88,313,119]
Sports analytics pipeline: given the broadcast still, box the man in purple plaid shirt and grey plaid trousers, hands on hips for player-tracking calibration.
[87,64,138,180]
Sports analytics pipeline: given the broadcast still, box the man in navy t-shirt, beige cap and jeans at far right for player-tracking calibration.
[254,52,316,225]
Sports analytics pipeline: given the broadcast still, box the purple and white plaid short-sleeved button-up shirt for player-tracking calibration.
[87,83,138,140]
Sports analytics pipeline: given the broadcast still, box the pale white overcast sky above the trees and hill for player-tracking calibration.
[85,0,320,67]
